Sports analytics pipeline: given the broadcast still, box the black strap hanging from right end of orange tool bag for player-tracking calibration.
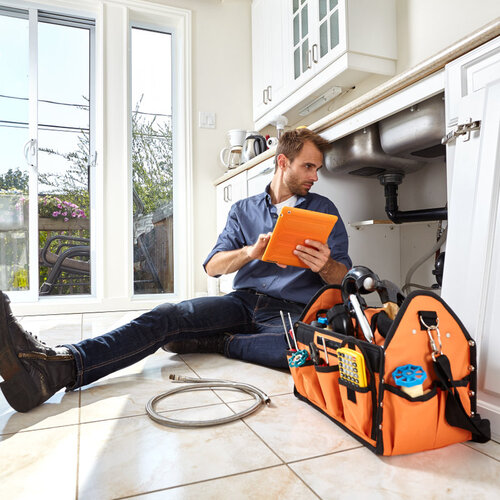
[434,354,491,443]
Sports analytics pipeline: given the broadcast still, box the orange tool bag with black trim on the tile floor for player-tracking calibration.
[287,285,490,455]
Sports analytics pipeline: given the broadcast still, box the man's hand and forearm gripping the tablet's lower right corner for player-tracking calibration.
[293,240,347,284]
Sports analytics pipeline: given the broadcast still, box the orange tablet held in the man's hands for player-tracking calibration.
[262,207,338,267]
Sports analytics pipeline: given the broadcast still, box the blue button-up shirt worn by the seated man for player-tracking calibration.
[203,186,352,304]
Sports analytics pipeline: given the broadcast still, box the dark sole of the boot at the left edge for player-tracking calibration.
[0,292,38,413]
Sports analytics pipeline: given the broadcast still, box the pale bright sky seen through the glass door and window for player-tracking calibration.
[0,11,172,191]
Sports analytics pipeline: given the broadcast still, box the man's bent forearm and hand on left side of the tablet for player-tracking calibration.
[205,233,271,276]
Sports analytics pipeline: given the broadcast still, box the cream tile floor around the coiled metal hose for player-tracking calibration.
[0,312,500,500]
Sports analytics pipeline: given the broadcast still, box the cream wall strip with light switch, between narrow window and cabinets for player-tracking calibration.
[152,0,253,291]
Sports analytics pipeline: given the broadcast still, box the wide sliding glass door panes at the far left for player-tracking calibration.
[0,8,94,295]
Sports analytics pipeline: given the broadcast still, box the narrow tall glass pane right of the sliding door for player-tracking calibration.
[131,27,174,294]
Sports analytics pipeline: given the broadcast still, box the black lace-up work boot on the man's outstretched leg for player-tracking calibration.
[0,292,76,412]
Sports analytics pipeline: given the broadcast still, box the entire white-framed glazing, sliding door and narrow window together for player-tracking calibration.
[0,0,193,314]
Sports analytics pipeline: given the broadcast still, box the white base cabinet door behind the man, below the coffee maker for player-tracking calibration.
[216,171,247,293]
